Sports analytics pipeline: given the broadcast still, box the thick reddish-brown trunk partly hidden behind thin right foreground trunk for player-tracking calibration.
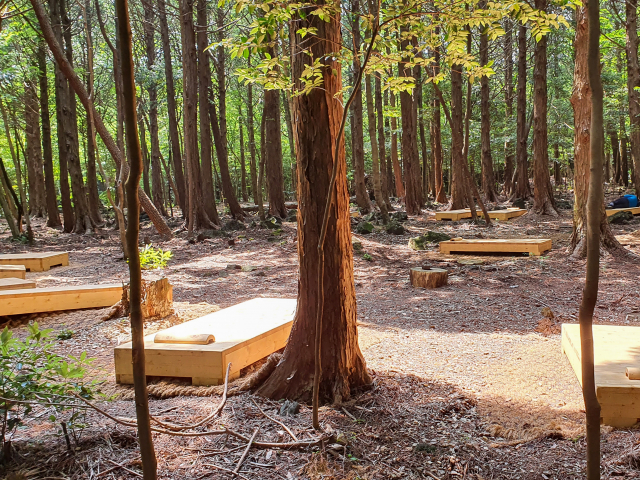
[570,1,623,258]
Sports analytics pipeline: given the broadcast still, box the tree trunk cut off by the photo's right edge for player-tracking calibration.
[625,0,640,195]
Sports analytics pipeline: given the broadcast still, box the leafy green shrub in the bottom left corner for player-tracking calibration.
[0,322,101,453]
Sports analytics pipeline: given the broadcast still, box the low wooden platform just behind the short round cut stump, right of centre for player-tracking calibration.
[440,238,551,255]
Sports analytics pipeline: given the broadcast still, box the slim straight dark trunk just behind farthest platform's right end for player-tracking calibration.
[511,24,531,198]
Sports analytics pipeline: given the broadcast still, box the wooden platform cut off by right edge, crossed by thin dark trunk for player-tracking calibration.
[562,324,640,427]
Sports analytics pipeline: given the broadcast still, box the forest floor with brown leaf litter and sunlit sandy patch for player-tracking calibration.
[0,189,640,480]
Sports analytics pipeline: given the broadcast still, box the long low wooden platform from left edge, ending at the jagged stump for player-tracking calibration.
[0,283,122,315]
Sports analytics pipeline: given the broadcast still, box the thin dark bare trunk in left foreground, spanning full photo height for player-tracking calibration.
[116,0,157,474]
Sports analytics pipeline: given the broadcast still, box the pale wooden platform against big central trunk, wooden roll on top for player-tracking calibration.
[114,298,296,385]
